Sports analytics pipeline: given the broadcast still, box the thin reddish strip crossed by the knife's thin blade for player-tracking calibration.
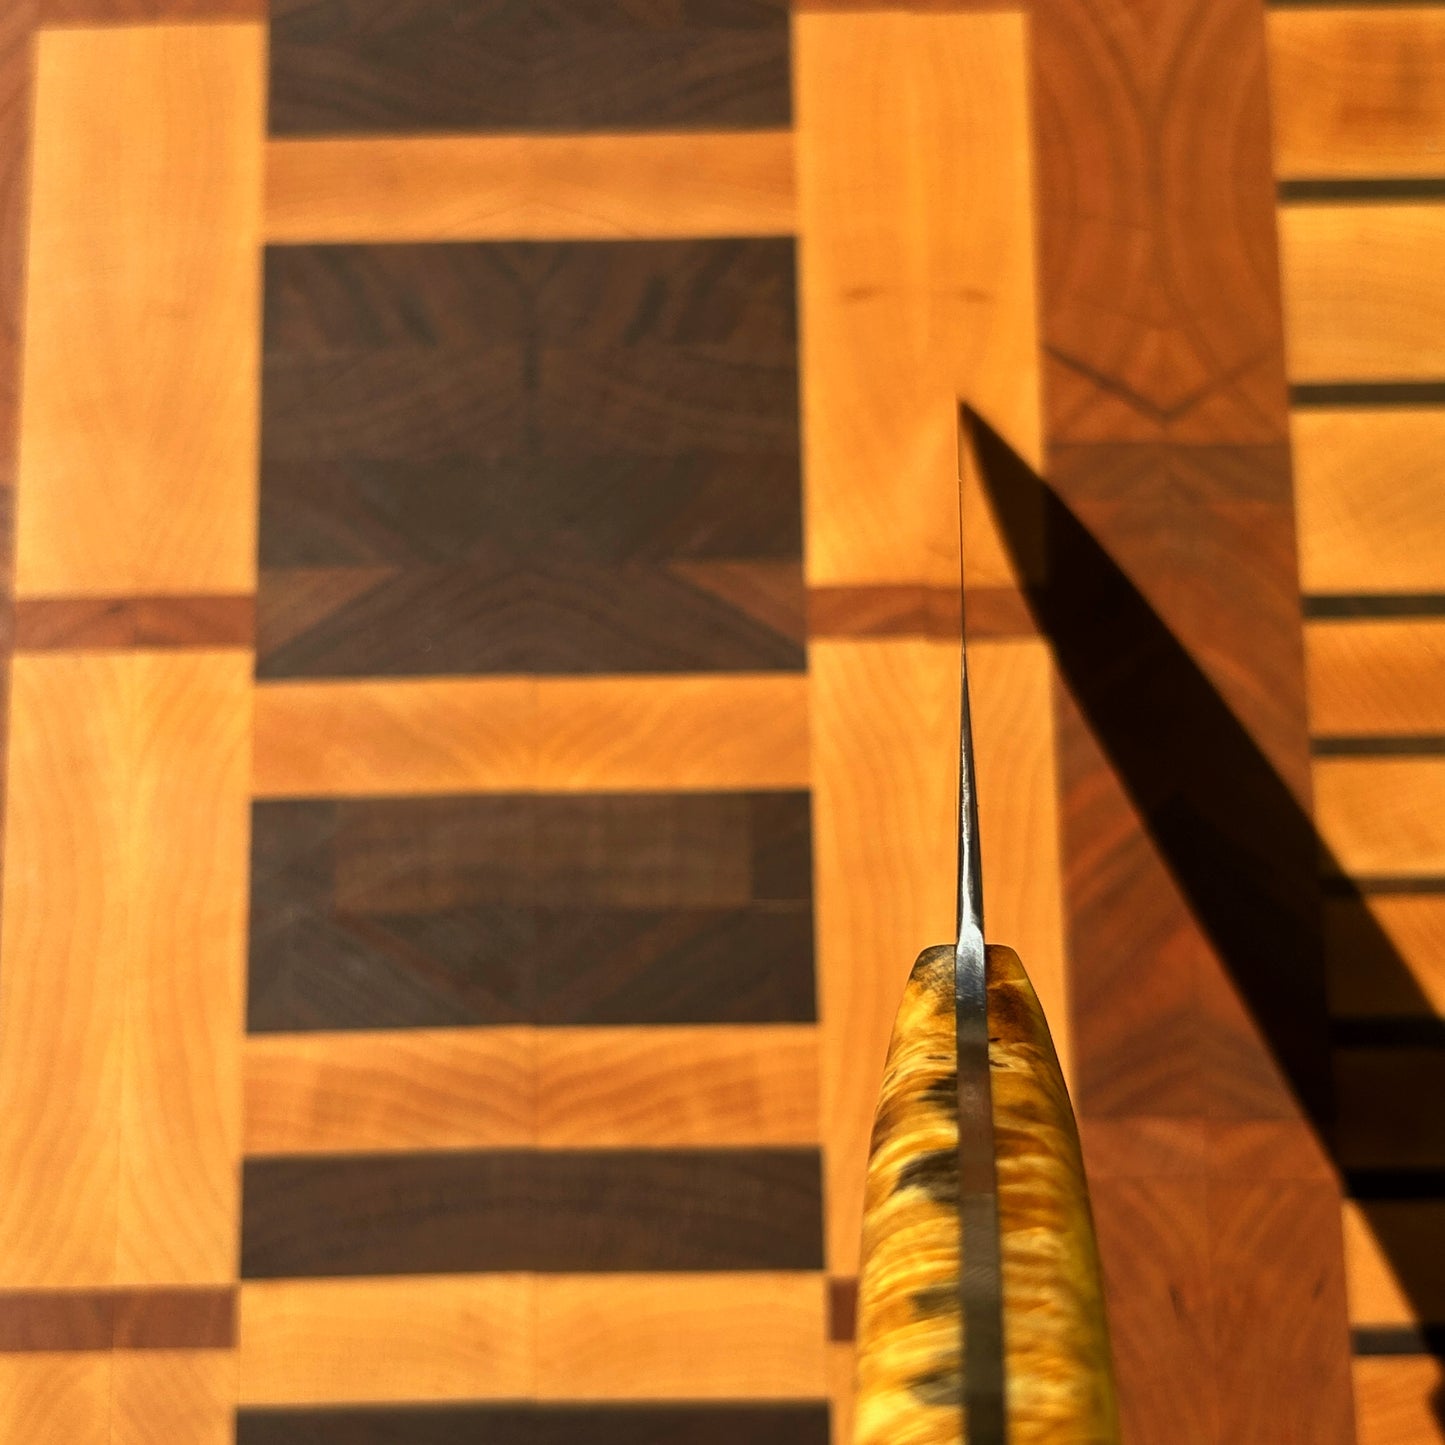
[808,582,1036,642]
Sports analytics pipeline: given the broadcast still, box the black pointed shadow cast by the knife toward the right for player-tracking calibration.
[962,406,1445,1398]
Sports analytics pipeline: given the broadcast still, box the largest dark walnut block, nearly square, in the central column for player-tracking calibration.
[257,238,803,678]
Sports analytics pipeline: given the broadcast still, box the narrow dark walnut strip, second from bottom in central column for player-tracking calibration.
[241,1149,822,1279]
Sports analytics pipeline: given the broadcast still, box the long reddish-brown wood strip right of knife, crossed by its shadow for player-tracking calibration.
[1033,0,1353,1445]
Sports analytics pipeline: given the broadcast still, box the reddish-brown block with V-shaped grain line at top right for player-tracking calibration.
[1034,0,1285,444]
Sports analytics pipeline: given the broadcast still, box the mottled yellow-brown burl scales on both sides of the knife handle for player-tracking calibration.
[854,945,1118,1445]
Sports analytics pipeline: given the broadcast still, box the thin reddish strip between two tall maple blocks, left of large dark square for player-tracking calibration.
[14,595,256,652]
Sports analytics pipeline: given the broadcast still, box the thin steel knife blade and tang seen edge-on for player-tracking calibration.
[954,412,1007,1445]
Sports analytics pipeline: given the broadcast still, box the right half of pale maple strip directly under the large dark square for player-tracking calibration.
[533,673,808,792]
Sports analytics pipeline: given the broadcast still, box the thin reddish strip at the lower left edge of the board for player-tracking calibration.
[0,1286,236,1354]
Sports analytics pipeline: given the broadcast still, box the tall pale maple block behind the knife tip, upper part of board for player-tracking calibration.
[793,6,1040,587]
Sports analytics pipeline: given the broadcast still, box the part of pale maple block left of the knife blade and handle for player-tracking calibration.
[811,639,959,1276]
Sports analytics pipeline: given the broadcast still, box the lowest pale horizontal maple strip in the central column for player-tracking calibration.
[240,1273,824,1404]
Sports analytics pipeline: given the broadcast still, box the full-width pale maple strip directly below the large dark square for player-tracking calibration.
[253,673,808,798]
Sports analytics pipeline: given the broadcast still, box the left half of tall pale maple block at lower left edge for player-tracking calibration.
[0,655,134,1288]
